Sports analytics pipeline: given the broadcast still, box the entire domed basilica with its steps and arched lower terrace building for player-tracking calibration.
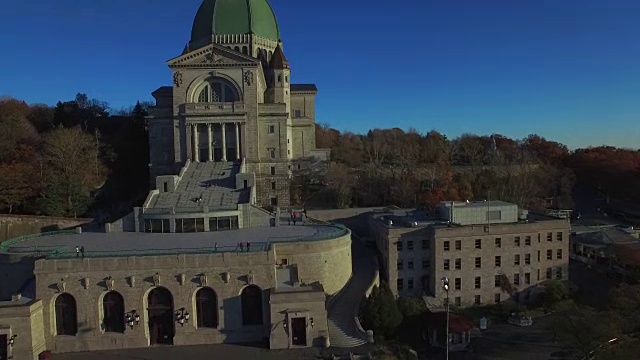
[0,0,353,359]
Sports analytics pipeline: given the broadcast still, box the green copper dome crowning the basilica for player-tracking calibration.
[191,0,280,43]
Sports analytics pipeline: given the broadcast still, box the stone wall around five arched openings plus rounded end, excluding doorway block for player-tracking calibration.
[26,234,351,352]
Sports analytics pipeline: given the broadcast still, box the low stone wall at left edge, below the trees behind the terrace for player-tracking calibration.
[0,214,93,242]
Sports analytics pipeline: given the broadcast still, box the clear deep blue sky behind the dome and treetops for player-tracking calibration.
[0,0,640,148]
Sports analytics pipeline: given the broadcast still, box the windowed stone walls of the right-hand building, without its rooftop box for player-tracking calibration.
[369,214,569,306]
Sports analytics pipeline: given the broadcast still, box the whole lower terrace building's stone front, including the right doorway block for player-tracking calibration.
[0,229,352,356]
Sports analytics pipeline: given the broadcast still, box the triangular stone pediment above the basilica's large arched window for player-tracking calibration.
[167,44,260,68]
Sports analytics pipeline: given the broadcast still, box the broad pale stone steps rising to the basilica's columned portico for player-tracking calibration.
[147,161,251,212]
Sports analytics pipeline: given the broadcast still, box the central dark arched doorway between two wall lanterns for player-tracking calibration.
[147,287,175,345]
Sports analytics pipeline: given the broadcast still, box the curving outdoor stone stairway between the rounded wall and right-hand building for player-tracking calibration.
[327,236,376,348]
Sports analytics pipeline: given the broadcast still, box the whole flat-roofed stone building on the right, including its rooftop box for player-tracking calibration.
[369,201,570,307]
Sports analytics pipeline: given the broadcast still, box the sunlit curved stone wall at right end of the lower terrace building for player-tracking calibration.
[273,231,352,295]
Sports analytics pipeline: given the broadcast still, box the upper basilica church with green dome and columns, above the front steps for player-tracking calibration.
[148,0,327,206]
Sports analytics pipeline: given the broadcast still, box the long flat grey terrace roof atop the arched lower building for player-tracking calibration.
[2,225,348,258]
